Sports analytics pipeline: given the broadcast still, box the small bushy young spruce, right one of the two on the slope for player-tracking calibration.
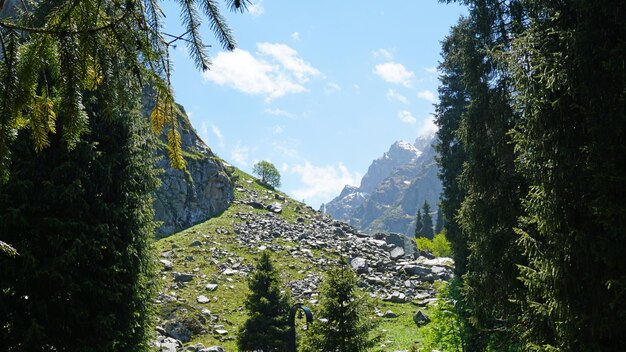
[303,263,379,352]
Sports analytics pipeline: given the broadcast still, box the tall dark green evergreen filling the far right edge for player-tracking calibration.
[502,0,626,351]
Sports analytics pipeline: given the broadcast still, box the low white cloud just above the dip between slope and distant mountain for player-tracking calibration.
[290,161,362,206]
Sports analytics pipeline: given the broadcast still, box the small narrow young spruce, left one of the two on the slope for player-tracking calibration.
[237,251,291,352]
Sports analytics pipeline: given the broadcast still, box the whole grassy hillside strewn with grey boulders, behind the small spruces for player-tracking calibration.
[156,168,451,351]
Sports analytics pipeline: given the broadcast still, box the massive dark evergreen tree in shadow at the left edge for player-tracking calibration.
[0,79,158,352]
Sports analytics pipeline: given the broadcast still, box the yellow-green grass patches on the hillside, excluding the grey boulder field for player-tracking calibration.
[156,170,432,351]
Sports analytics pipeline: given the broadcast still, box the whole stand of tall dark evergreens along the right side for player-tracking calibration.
[437,0,626,351]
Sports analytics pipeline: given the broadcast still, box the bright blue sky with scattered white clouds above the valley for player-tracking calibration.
[164,0,465,209]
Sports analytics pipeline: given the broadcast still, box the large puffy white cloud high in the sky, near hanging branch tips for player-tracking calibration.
[203,43,321,101]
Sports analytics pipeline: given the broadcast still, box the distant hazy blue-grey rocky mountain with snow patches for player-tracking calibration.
[325,136,442,236]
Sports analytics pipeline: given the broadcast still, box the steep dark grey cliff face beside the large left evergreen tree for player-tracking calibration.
[143,94,234,238]
